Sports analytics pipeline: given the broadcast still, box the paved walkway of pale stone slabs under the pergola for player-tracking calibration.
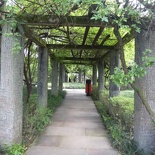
[26,89,117,155]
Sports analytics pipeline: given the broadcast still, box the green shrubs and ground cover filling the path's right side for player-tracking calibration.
[92,87,144,155]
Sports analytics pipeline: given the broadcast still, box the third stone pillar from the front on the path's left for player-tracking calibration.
[51,60,58,95]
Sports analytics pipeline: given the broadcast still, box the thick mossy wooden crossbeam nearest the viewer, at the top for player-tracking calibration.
[23,15,108,28]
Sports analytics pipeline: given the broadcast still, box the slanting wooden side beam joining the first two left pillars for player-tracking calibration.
[23,25,46,47]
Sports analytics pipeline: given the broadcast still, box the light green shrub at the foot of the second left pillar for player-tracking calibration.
[23,94,52,144]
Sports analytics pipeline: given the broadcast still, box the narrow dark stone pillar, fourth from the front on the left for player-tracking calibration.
[59,63,64,91]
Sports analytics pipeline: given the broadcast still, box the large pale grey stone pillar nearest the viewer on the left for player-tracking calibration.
[0,23,24,146]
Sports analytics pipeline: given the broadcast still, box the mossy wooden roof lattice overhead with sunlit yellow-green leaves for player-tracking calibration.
[21,3,134,64]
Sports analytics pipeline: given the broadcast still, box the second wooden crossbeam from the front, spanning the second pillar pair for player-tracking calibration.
[47,44,114,51]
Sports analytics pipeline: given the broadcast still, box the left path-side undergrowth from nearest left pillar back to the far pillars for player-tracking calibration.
[23,88,66,146]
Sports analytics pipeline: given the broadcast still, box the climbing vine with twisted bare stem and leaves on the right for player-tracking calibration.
[89,0,155,121]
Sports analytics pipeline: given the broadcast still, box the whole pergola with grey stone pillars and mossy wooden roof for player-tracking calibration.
[0,1,155,154]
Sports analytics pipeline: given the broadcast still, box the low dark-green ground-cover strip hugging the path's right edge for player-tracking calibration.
[95,101,142,155]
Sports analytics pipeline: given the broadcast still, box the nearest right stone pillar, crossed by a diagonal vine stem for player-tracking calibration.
[134,27,155,154]
